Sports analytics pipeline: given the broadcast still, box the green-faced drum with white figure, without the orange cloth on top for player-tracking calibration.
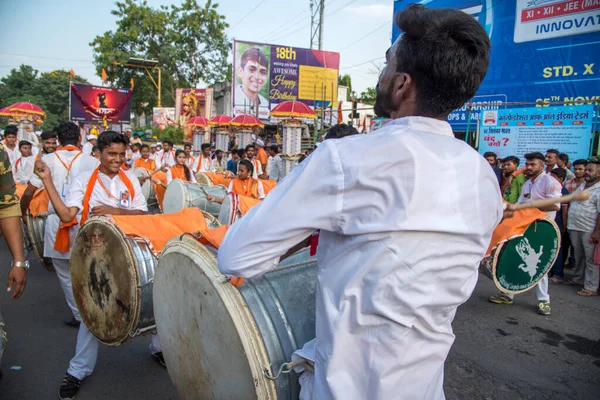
[479,218,561,294]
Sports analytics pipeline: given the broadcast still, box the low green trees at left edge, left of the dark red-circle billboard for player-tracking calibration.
[0,65,89,129]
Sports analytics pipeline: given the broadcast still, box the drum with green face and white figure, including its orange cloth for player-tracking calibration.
[479,209,561,294]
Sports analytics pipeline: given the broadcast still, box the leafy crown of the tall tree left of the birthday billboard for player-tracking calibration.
[90,0,231,115]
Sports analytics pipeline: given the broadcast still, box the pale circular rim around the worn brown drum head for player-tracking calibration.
[71,215,142,347]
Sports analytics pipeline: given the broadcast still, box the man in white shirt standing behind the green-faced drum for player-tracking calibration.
[489,151,561,315]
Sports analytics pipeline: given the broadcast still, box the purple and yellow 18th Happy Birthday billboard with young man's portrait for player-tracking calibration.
[231,41,340,119]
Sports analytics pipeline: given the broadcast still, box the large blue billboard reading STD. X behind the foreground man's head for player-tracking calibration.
[392,0,600,129]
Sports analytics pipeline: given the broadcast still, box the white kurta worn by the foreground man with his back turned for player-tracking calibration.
[218,117,502,400]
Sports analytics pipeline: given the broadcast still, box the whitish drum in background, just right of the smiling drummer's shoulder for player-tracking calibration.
[163,179,227,217]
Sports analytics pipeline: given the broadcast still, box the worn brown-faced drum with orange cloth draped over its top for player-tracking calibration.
[71,208,214,346]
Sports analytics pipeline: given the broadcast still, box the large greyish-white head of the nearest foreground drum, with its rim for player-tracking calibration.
[154,237,277,400]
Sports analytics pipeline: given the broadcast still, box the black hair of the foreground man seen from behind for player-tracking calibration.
[394,4,491,117]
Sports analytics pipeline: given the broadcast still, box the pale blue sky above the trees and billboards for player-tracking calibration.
[0,0,393,94]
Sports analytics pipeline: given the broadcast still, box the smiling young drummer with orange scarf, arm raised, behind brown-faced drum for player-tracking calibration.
[35,131,164,399]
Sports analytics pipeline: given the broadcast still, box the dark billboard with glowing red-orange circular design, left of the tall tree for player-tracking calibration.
[71,83,133,124]
